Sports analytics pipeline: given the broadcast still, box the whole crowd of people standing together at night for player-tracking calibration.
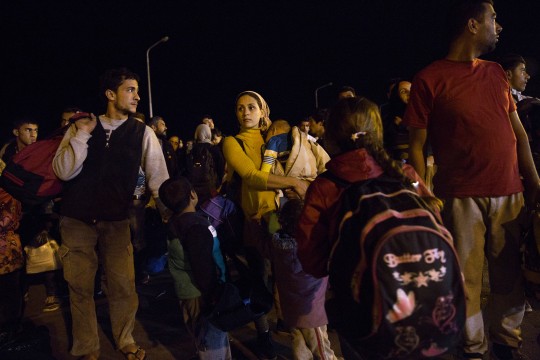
[0,0,540,360]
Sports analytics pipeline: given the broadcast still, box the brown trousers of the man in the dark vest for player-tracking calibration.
[60,217,139,356]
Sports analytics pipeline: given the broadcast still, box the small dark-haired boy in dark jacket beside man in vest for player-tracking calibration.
[159,177,231,360]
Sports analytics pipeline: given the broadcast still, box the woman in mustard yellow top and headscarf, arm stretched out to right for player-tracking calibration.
[223,91,309,359]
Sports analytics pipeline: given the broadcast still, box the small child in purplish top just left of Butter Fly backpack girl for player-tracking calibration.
[271,199,337,360]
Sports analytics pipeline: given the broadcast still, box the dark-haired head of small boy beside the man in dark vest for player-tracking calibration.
[159,176,197,213]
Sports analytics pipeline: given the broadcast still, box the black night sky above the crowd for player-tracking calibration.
[0,0,540,140]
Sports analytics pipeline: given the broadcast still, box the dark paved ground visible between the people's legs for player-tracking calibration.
[19,275,540,360]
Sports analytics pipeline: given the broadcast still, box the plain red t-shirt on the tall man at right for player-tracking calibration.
[403,59,523,198]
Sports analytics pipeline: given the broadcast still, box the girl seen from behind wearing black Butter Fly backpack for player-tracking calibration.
[296,97,465,359]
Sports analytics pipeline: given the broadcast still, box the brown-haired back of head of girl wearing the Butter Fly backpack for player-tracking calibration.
[325,97,383,153]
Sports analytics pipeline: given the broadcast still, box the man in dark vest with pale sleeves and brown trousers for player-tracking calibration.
[53,69,168,359]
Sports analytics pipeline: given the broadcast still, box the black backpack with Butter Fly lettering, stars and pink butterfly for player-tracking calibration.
[321,171,465,359]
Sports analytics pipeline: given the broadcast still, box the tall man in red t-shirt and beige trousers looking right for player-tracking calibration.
[404,0,539,359]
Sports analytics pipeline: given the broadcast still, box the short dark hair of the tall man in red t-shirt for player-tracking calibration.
[446,0,493,43]
